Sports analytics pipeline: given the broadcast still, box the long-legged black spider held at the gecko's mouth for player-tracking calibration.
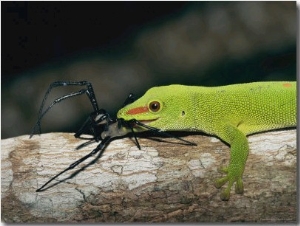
[30,81,195,192]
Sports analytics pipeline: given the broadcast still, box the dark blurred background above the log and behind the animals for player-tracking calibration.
[1,1,297,139]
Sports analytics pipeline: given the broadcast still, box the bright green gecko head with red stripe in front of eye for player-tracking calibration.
[117,85,186,130]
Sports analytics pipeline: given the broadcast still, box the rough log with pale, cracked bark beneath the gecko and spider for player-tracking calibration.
[1,130,297,223]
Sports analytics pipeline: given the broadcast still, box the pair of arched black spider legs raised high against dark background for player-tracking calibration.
[30,81,99,138]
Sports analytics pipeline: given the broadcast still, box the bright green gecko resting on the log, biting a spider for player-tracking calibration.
[117,82,296,200]
